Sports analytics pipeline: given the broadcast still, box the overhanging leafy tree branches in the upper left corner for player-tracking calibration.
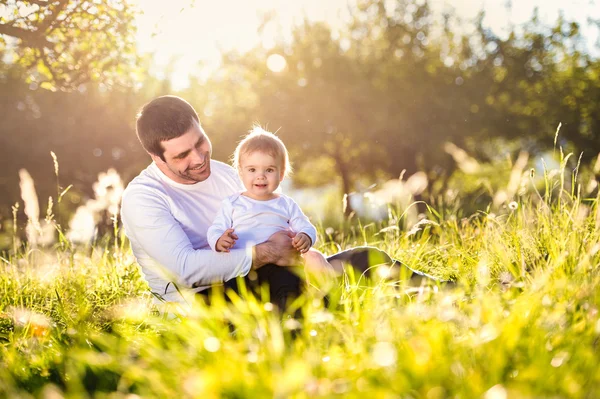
[0,0,136,89]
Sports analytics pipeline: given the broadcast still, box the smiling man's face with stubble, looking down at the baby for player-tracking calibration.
[150,121,212,184]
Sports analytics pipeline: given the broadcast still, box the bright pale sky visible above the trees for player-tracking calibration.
[133,0,600,88]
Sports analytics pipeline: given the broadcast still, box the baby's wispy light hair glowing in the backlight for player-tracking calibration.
[232,125,292,177]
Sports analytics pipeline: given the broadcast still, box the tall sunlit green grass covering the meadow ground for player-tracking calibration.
[0,171,600,399]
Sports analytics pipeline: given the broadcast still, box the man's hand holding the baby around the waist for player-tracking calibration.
[252,231,302,269]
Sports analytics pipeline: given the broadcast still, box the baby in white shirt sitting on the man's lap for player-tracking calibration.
[207,127,332,272]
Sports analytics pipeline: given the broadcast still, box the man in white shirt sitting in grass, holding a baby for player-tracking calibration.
[121,96,440,307]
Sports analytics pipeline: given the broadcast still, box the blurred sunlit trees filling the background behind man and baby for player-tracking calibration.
[0,0,600,225]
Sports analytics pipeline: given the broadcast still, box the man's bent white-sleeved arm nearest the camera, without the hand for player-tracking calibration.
[122,190,252,287]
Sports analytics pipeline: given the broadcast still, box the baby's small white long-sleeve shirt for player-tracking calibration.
[207,193,317,250]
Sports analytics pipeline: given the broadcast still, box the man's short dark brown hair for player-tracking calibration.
[136,96,200,161]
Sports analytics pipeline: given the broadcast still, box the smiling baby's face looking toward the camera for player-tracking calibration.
[239,151,283,200]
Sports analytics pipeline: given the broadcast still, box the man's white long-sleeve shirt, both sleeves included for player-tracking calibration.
[121,160,252,302]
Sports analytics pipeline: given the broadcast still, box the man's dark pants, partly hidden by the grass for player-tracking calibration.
[199,247,446,311]
